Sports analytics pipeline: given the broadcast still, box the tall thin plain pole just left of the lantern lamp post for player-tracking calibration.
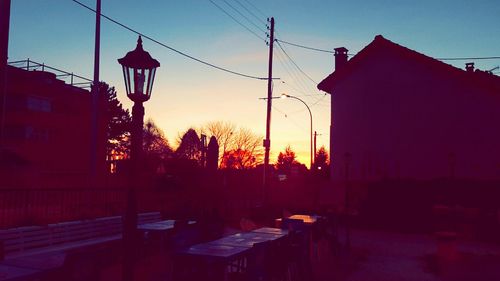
[90,0,101,188]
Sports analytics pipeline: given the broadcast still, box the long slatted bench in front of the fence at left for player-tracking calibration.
[0,212,161,260]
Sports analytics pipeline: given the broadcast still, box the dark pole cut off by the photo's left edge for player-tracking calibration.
[0,0,10,148]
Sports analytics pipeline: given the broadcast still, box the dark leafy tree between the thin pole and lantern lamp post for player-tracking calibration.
[99,82,132,158]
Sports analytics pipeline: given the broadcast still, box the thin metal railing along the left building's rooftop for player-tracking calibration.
[8,59,93,89]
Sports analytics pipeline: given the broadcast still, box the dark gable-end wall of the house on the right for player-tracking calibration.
[332,48,500,180]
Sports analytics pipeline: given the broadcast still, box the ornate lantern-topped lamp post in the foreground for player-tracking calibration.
[118,36,160,280]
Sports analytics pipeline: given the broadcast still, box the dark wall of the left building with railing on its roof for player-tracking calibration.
[2,67,105,187]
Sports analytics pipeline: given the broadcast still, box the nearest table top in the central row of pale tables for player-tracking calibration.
[179,242,249,260]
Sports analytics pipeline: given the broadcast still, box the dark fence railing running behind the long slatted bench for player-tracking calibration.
[0,188,175,229]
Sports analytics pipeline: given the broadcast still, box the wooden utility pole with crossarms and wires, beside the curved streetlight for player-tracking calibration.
[262,17,274,201]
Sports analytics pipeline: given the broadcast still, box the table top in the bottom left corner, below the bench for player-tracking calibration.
[0,252,66,270]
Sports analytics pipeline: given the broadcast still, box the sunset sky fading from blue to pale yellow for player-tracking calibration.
[9,0,500,164]
